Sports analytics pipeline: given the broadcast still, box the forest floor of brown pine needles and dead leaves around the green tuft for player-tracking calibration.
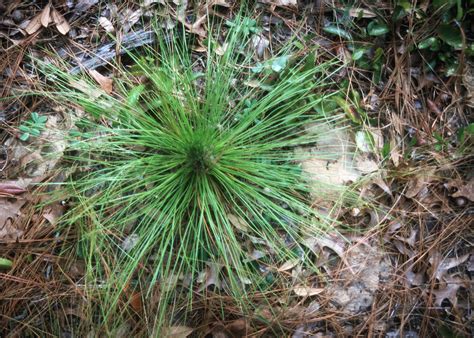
[0,0,474,338]
